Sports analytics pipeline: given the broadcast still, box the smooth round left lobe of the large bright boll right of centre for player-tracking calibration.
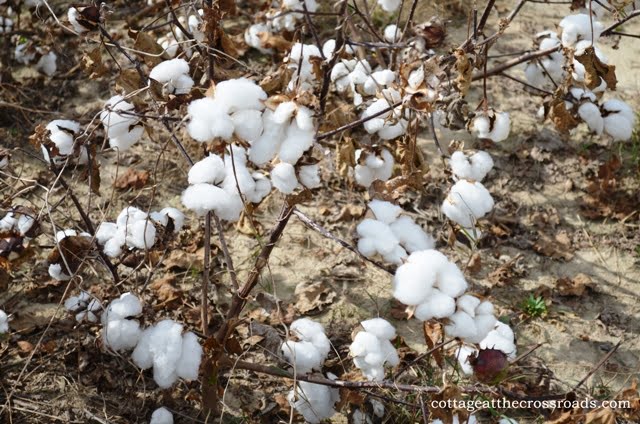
[393,262,436,305]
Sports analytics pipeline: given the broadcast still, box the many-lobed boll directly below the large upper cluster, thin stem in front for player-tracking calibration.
[182,145,271,221]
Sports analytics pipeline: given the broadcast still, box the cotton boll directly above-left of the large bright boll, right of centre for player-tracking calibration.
[356,199,435,265]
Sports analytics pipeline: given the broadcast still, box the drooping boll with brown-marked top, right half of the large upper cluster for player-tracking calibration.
[249,100,317,166]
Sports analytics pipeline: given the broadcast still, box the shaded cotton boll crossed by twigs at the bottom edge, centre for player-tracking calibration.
[287,380,340,424]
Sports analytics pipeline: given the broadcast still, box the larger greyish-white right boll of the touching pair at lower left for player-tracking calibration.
[131,319,203,389]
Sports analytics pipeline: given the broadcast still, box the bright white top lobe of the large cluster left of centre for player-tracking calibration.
[215,78,267,113]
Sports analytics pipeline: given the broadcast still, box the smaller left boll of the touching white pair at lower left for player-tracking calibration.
[102,293,142,352]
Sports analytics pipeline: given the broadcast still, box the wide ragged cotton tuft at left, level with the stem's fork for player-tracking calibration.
[96,206,184,258]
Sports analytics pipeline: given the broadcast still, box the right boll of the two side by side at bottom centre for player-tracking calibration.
[349,318,400,381]
